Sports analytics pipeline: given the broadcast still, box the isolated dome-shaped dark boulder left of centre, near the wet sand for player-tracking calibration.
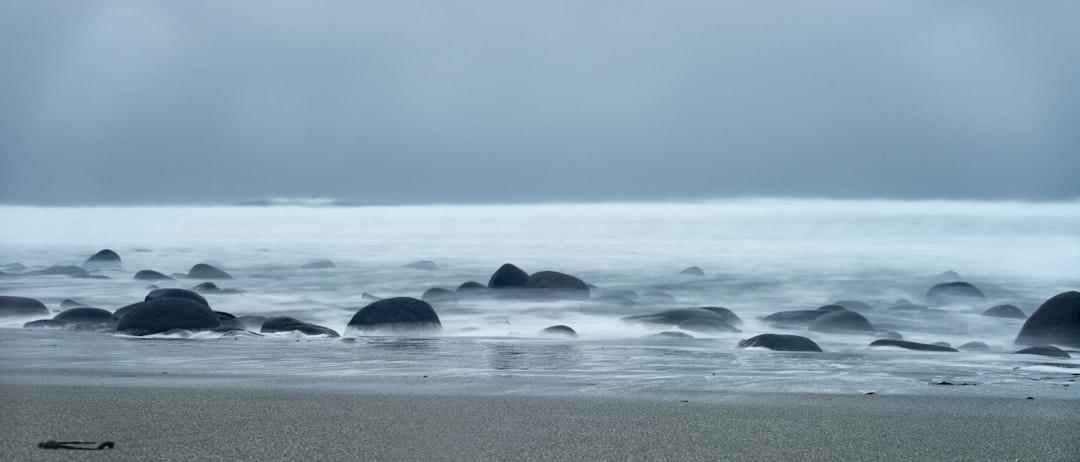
[347,297,443,334]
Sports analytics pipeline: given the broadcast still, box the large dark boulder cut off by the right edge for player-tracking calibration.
[1016,290,1080,348]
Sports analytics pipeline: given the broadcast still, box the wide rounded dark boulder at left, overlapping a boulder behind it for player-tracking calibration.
[114,297,221,336]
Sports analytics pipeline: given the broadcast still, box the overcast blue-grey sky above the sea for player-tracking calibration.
[0,0,1080,205]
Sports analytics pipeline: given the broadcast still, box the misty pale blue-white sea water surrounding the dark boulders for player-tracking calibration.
[0,199,1080,398]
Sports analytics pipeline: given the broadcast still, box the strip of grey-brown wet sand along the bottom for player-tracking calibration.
[0,379,1080,461]
